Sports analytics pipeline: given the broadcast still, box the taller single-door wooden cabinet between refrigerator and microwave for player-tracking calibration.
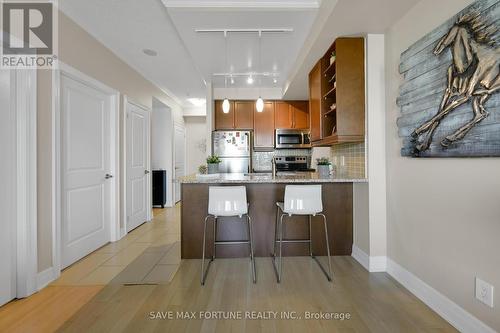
[253,102,275,149]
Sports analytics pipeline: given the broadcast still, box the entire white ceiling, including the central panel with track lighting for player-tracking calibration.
[59,0,417,106]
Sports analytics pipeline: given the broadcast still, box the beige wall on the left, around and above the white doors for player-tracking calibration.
[38,13,183,272]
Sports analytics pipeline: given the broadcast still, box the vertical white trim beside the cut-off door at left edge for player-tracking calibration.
[11,69,38,298]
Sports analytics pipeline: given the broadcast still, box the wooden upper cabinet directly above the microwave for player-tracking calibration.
[274,101,309,129]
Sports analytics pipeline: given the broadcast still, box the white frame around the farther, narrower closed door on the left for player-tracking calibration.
[120,95,153,233]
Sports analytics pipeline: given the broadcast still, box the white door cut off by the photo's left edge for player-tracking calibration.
[0,70,16,306]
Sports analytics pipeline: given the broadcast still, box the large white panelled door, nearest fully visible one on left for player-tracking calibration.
[61,75,115,268]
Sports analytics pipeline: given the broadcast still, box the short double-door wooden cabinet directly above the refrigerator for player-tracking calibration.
[215,101,255,130]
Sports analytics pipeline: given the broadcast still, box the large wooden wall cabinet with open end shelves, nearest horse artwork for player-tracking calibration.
[309,38,365,146]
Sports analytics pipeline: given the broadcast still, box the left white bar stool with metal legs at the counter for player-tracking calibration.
[201,186,256,286]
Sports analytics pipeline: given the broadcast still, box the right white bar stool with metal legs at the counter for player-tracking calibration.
[273,185,332,283]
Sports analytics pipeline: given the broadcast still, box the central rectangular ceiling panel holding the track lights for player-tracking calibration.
[168,8,317,88]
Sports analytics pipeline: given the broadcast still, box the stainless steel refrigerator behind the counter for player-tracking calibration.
[212,131,252,173]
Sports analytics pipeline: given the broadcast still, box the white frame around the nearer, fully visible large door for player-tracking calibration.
[52,61,120,279]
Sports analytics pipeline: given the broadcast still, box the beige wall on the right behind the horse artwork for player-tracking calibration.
[386,0,500,330]
